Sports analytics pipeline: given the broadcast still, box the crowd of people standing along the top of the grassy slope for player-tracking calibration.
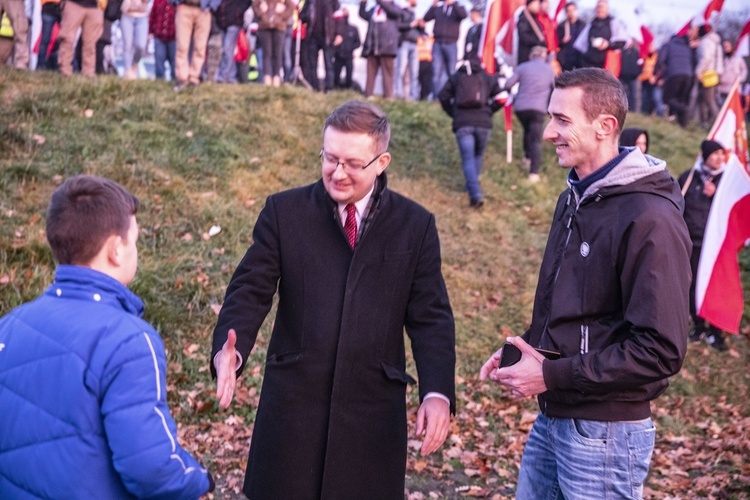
[0,0,748,114]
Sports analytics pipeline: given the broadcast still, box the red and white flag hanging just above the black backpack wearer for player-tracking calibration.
[479,0,525,75]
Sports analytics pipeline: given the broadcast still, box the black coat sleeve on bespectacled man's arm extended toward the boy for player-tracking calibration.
[209,196,281,376]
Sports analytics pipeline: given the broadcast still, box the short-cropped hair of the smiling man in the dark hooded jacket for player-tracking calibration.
[555,68,628,135]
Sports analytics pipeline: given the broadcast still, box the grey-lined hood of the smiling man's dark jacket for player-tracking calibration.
[572,147,685,211]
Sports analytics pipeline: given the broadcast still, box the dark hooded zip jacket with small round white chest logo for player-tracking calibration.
[523,148,691,421]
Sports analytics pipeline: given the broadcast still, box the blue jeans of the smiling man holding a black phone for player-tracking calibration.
[516,413,656,500]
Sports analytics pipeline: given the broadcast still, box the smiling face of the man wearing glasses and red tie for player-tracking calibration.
[322,127,391,204]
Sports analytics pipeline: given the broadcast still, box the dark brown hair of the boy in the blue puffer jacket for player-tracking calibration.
[47,175,140,265]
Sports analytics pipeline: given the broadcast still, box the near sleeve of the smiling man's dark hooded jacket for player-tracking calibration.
[542,203,691,394]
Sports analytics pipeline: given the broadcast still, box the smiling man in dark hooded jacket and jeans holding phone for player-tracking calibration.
[480,68,690,500]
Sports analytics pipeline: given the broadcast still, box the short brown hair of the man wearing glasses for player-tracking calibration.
[323,101,391,153]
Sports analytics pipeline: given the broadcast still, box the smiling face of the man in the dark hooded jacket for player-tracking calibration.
[544,87,606,179]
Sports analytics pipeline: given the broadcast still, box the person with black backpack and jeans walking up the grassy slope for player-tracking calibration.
[438,60,502,209]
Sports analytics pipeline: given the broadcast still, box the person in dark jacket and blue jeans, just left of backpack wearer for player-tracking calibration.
[424,0,466,99]
